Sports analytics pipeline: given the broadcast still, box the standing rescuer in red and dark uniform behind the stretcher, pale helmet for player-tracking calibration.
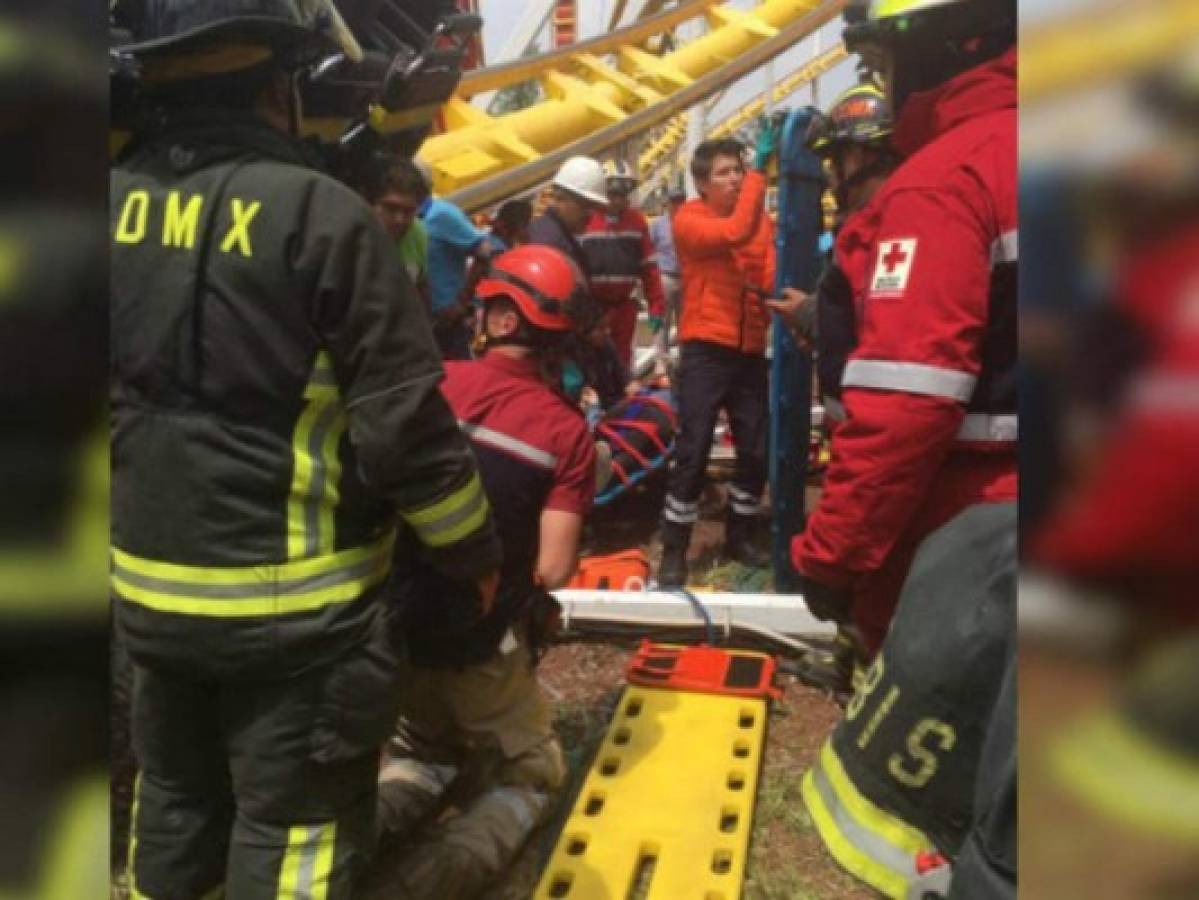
[579,159,665,369]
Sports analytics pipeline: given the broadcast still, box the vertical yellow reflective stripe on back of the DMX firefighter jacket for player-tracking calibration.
[287,350,347,560]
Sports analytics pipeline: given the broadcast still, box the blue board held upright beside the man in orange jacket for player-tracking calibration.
[769,107,825,593]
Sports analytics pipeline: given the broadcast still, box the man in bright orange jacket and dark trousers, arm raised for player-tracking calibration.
[658,127,778,587]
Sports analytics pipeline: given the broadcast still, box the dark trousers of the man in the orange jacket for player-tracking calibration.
[667,340,769,524]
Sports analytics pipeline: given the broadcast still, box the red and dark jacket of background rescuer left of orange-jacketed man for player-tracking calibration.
[579,209,665,316]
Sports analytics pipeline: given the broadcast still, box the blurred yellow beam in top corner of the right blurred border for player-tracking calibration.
[1020,0,1199,101]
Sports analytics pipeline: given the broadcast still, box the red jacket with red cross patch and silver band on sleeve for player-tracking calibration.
[791,49,1017,587]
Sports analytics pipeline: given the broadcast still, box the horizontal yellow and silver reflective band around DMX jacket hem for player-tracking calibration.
[110,533,394,618]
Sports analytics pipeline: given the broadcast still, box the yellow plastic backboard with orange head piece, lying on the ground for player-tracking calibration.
[534,646,772,900]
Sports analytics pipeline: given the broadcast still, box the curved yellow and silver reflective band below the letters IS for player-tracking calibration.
[802,741,936,900]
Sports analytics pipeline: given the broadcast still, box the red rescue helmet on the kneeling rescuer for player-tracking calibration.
[475,243,582,331]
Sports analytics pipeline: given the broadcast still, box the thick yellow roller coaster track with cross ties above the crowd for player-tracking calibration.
[412,0,846,211]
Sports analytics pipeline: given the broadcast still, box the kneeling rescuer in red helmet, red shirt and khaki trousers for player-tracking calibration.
[379,244,596,900]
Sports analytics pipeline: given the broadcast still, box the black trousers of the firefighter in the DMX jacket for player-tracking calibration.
[129,606,402,900]
